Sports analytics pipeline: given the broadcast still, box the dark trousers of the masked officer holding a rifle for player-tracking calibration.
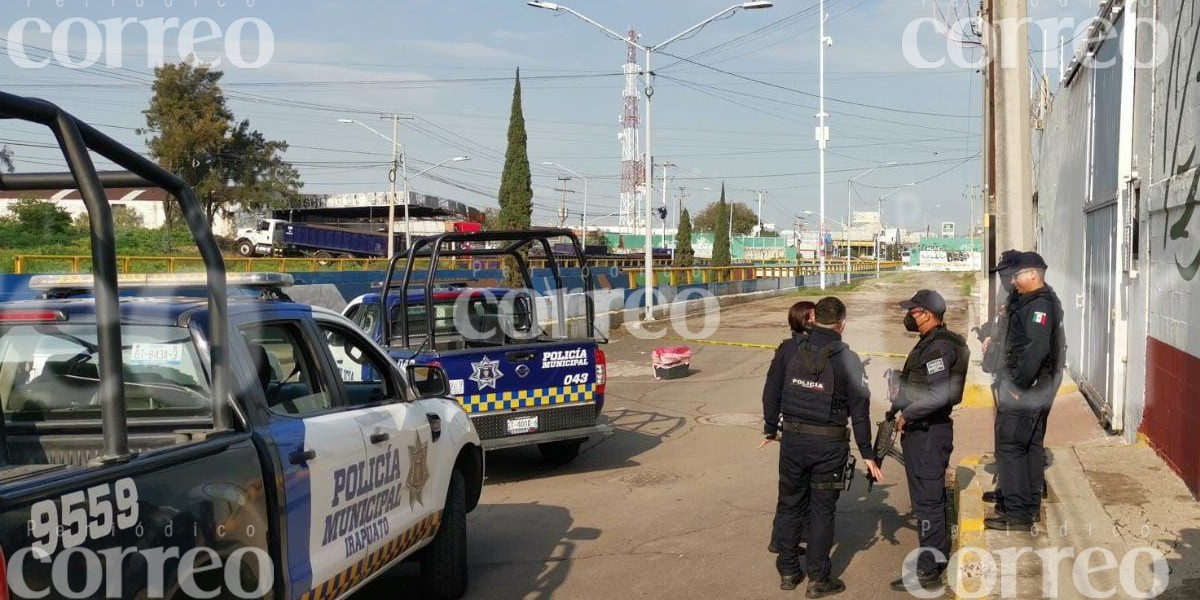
[900,422,954,571]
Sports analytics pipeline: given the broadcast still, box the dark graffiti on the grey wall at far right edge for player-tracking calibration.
[1163,0,1200,281]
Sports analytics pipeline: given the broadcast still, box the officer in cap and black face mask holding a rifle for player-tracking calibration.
[890,289,971,592]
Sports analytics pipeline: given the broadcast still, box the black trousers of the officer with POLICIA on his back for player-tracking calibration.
[773,432,850,581]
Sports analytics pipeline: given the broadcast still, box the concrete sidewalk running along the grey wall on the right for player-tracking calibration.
[948,282,1200,600]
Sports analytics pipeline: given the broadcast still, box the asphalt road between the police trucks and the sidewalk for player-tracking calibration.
[359,274,968,600]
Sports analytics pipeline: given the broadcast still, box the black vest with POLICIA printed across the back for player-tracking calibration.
[780,337,850,426]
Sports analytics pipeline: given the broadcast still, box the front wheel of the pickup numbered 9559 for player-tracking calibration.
[421,469,467,600]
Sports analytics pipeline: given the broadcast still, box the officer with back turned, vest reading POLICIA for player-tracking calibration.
[760,296,883,598]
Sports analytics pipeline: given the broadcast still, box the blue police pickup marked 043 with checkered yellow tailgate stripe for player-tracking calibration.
[342,229,612,464]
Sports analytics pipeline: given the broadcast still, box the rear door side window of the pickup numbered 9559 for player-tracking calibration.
[241,324,334,416]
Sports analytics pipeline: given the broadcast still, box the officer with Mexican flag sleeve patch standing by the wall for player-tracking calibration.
[984,252,1067,532]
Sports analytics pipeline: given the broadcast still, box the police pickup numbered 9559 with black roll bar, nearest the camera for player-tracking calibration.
[0,92,484,600]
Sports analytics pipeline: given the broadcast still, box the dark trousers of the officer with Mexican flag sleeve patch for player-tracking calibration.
[996,382,1057,521]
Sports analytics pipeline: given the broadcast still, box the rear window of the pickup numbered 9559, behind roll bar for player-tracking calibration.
[0,323,212,421]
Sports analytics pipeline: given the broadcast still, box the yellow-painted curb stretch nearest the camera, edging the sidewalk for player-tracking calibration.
[948,455,988,599]
